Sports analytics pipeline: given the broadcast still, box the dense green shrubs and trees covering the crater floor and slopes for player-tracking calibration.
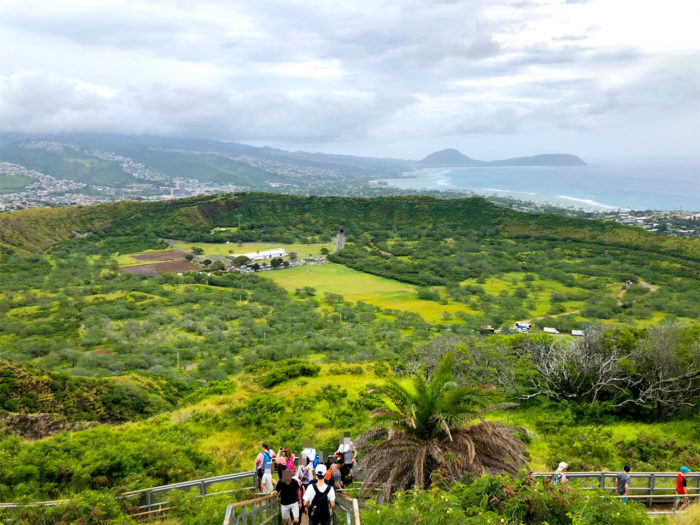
[0,194,700,523]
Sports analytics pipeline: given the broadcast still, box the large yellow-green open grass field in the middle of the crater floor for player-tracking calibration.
[265,263,475,322]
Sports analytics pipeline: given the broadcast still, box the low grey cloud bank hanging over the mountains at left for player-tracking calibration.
[0,74,414,142]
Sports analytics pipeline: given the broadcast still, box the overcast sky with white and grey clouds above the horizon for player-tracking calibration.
[0,0,700,159]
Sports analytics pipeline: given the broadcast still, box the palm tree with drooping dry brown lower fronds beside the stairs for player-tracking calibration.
[355,352,525,503]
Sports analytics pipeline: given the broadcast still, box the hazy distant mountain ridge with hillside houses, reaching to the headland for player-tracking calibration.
[0,132,585,212]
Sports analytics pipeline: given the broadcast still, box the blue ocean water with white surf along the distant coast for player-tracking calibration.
[385,159,700,211]
